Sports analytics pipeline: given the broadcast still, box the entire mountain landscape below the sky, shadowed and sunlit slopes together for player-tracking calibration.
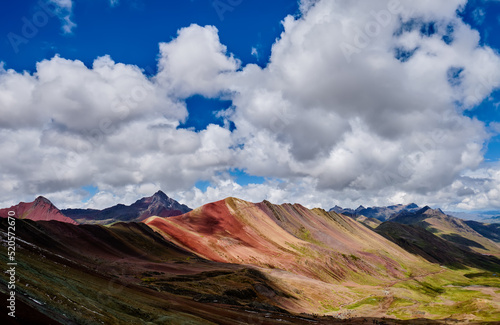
[0,191,500,324]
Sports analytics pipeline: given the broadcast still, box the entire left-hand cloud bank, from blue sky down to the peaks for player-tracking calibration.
[0,26,233,206]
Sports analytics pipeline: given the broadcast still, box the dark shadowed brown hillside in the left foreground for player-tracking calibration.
[0,219,467,325]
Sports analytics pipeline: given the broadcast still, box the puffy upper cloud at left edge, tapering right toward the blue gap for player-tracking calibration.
[0,56,187,129]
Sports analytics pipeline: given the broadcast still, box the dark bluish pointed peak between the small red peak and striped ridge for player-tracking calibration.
[61,191,191,224]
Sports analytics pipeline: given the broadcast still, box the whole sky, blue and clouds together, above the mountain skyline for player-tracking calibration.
[0,0,500,210]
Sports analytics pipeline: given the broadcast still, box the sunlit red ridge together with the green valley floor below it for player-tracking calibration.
[144,198,500,324]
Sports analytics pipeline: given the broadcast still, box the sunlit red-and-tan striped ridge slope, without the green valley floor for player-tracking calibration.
[145,198,436,283]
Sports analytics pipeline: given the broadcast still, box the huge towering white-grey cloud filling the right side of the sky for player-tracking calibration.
[226,1,500,197]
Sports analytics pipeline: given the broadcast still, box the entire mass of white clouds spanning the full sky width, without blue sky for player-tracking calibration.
[0,0,500,213]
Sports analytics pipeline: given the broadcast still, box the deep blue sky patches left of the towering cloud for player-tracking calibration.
[0,0,299,196]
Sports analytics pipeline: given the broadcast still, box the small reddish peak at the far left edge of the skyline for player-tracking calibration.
[0,196,77,224]
